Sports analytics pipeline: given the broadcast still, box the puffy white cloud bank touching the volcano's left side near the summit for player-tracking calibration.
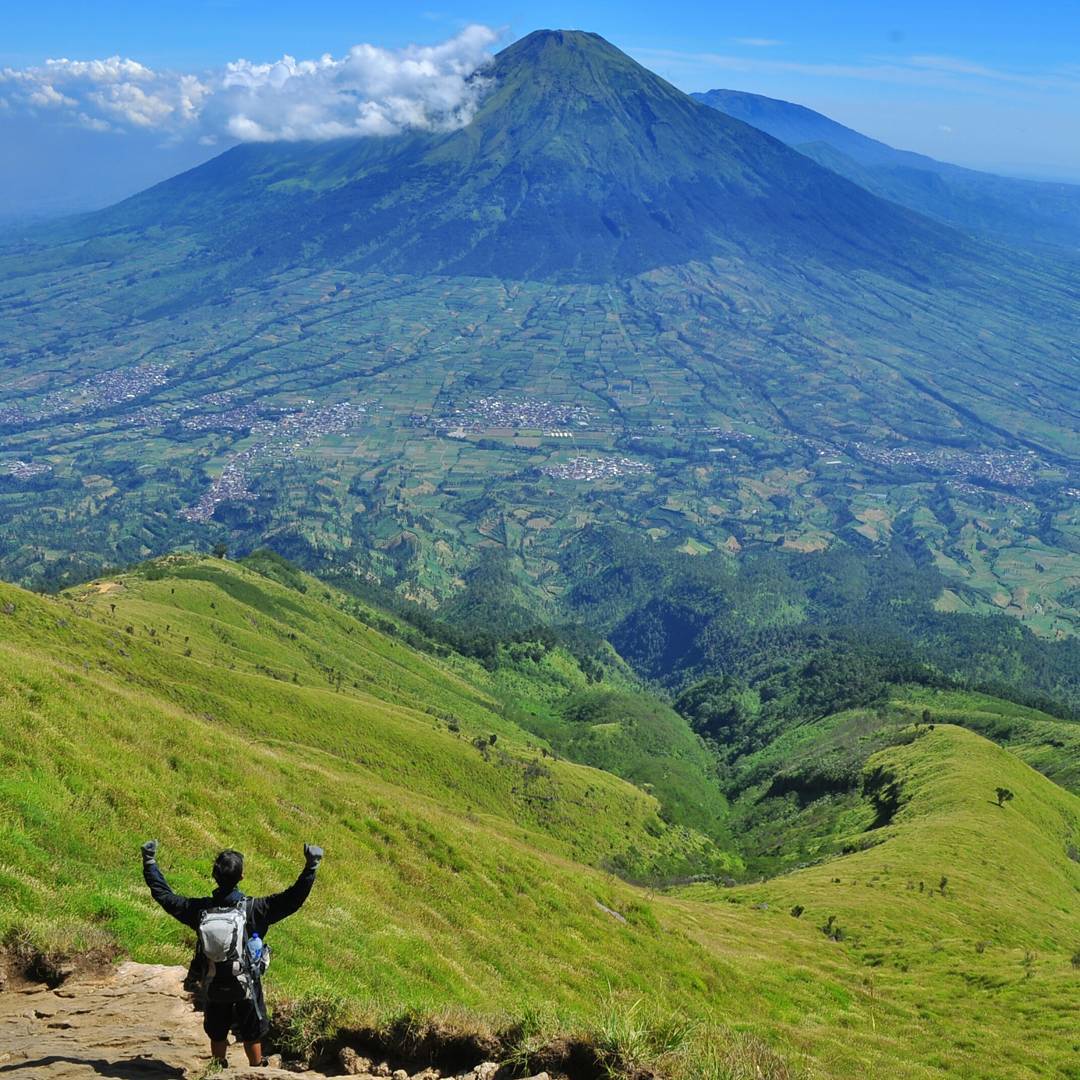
[0,26,499,146]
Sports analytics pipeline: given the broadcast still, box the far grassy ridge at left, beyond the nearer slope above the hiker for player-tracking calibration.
[4,556,725,876]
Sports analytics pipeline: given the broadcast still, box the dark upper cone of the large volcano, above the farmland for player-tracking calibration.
[42,31,959,281]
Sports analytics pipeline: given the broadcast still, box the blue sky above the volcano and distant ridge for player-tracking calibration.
[0,0,1080,217]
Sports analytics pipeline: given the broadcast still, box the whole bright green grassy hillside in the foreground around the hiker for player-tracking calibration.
[0,559,1080,1080]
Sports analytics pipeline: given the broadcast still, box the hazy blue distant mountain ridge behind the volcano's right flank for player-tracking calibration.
[690,90,1080,248]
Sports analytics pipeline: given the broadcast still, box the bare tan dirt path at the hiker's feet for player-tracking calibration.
[0,962,537,1080]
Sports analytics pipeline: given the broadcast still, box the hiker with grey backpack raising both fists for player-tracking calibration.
[143,840,323,1066]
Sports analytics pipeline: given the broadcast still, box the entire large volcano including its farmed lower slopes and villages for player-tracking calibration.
[0,32,1080,639]
